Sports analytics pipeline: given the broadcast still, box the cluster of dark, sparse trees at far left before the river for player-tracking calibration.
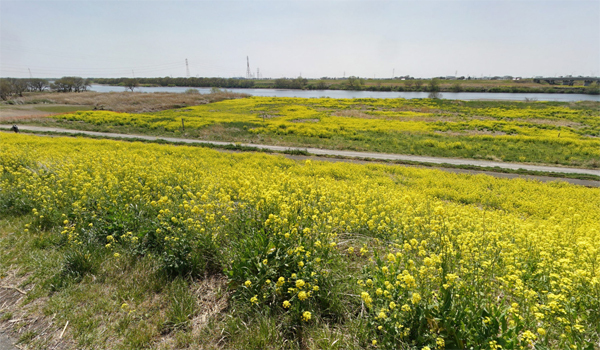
[0,77,92,100]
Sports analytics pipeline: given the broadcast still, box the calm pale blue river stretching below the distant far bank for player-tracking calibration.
[90,84,600,102]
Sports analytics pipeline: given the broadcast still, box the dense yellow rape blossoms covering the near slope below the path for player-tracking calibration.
[0,134,600,349]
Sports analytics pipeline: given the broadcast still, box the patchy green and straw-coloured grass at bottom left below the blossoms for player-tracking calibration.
[0,215,366,350]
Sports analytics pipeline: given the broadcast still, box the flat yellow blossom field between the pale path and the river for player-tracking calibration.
[55,97,600,168]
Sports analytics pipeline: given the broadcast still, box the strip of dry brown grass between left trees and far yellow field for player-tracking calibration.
[5,91,249,113]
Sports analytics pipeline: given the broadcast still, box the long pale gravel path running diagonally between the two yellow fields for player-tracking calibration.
[0,125,600,176]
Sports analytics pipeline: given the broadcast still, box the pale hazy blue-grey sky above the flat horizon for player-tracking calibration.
[0,0,600,78]
